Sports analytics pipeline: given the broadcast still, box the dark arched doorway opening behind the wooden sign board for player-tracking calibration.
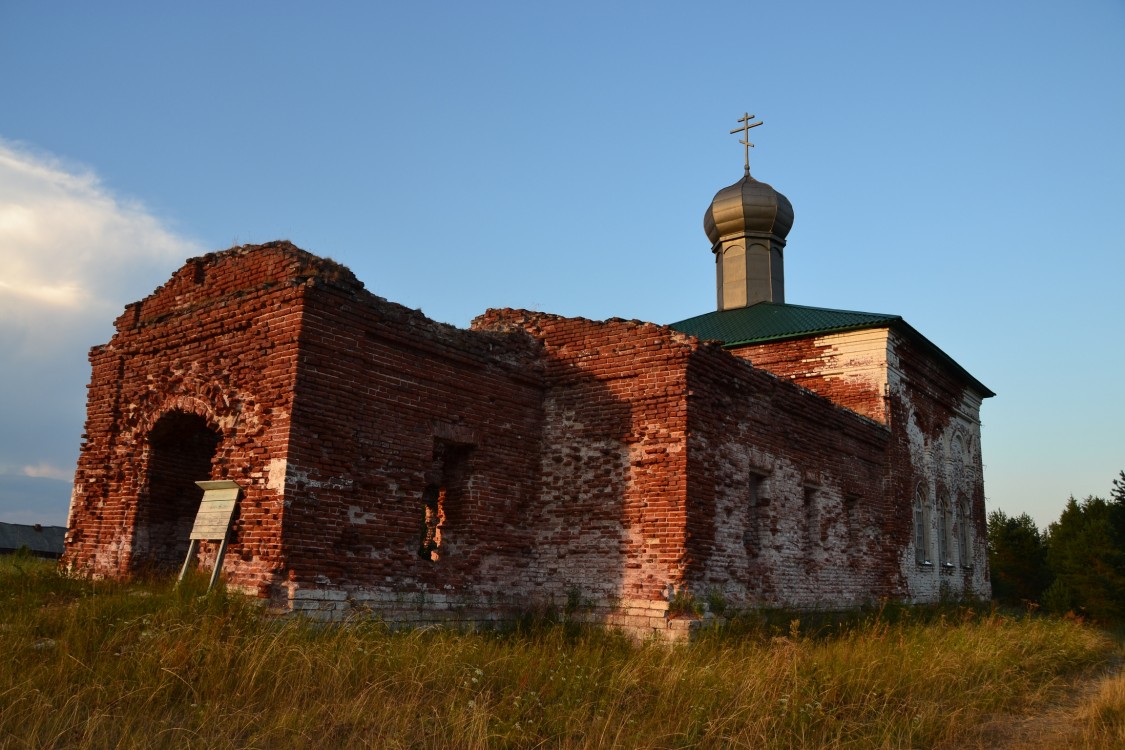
[131,412,221,572]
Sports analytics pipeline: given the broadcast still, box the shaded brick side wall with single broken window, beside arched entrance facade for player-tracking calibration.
[279,281,542,622]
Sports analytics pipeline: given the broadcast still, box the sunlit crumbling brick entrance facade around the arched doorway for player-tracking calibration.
[63,243,315,593]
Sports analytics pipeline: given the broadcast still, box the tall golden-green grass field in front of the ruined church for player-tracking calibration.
[0,558,1125,749]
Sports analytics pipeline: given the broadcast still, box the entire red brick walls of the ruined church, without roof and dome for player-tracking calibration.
[63,242,988,639]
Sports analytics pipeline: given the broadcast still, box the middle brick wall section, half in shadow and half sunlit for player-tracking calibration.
[474,310,694,631]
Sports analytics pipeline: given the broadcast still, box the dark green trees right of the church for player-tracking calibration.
[988,470,1125,623]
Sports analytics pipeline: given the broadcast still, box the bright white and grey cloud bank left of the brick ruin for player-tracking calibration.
[0,138,204,503]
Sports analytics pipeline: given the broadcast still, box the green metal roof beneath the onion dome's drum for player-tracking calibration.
[668,302,996,398]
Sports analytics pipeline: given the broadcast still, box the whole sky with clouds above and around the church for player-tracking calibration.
[0,0,1125,525]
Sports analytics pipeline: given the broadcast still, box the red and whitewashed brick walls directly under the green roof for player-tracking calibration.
[732,327,990,602]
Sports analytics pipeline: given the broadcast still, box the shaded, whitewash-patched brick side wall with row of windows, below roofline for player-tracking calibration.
[689,344,910,608]
